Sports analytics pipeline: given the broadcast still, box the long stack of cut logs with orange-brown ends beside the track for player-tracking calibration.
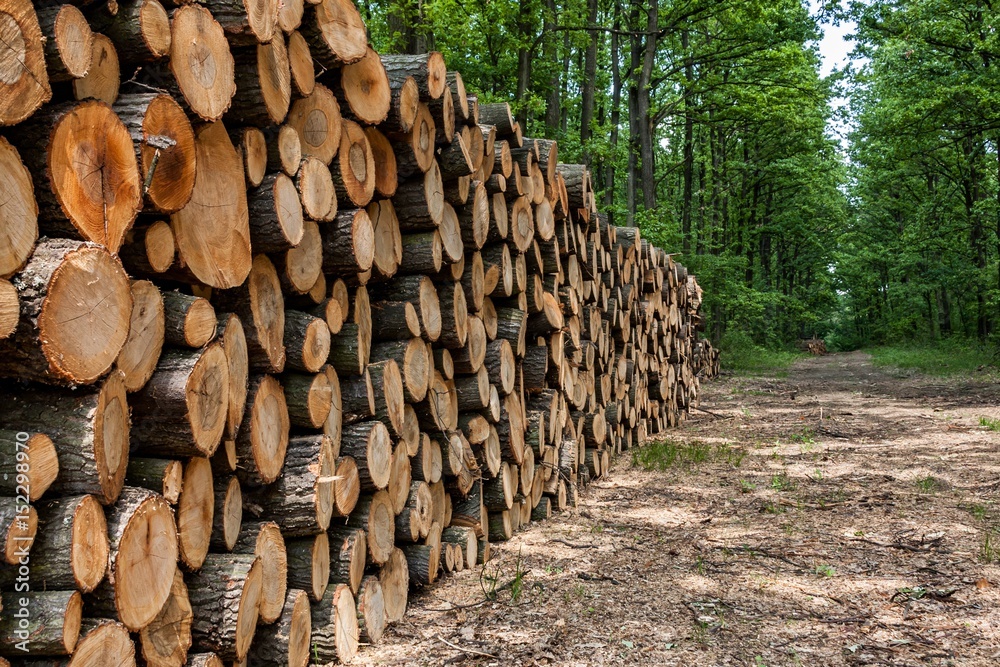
[0,0,711,667]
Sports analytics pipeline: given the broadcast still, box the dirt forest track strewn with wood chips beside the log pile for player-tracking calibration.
[355,353,1000,667]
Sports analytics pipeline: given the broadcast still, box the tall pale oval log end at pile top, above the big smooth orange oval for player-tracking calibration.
[170,5,236,122]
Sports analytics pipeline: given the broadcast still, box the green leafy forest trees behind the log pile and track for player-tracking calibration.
[362,0,1000,347]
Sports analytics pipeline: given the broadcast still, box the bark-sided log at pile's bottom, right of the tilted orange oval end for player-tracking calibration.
[188,554,260,661]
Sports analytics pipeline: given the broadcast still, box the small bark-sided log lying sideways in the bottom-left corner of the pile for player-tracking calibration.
[0,591,83,656]
